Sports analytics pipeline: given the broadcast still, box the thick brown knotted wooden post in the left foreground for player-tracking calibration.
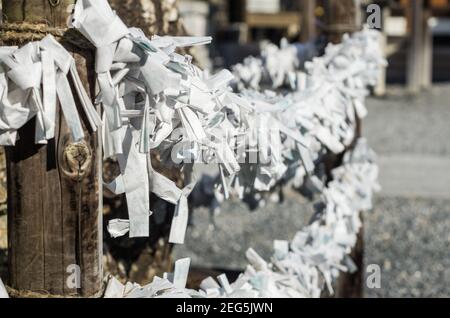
[1,0,103,297]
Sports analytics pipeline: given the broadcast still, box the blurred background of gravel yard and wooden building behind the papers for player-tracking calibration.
[0,0,450,297]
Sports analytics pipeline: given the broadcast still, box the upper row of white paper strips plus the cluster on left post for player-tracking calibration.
[0,0,383,298]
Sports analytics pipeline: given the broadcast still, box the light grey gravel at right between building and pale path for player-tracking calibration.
[363,84,450,156]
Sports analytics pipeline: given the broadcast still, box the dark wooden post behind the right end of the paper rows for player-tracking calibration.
[326,0,365,298]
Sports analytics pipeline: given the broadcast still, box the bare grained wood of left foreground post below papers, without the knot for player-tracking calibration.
[7,47,103,296]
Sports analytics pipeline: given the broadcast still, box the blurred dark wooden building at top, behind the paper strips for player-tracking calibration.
[178,0,450,84]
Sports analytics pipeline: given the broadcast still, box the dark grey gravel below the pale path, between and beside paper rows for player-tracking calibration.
[174,197,450,297]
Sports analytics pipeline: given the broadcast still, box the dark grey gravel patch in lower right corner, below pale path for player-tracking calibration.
[365,198,450,297]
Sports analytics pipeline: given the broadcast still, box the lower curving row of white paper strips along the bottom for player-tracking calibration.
[105,139,379,298]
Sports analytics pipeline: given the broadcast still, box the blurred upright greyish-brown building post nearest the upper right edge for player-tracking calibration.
[406,0,424,94]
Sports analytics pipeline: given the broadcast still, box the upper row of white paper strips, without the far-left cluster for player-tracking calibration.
[71,0,380,244]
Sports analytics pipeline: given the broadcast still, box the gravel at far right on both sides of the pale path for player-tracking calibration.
[364,84,450,297]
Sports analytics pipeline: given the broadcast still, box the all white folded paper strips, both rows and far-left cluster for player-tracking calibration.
[0,0,385,297]
